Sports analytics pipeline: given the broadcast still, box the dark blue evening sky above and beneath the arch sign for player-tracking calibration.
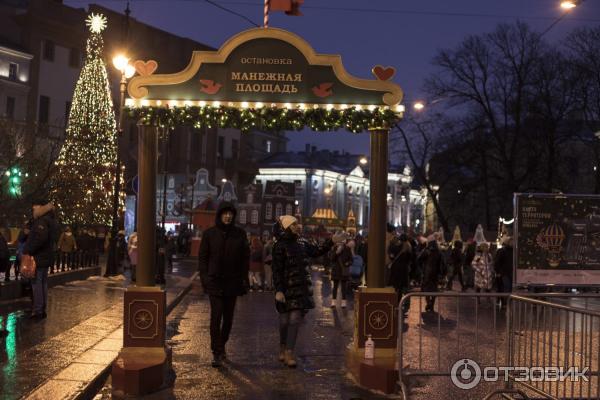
[65,0,600,153]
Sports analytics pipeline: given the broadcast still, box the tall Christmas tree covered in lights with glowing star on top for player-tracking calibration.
[52,14,117,225]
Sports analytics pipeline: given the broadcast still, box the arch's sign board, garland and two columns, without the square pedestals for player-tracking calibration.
[126,28,404,287]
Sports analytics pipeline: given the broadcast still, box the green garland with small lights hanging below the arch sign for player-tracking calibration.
[126,106,399,133]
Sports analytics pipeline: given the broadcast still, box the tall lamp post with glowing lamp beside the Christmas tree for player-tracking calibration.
[104,54,135,276]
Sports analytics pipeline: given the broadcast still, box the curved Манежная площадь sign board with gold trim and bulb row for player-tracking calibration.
[127,28,404,113]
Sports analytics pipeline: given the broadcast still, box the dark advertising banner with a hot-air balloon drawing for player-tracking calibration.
[515,194,600,286]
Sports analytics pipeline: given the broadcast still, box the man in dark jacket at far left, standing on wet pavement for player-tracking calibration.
[23,198,58,319]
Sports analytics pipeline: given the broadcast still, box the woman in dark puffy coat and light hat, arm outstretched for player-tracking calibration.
[272,215,333,368]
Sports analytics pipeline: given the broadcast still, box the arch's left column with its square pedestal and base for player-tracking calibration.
[112,125,171,398]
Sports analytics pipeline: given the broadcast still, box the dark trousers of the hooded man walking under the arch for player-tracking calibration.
[209,295,237,354]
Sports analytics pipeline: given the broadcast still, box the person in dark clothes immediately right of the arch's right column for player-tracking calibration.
[388,233,412,317]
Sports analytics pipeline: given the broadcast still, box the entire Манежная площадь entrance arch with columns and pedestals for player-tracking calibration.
[113,28,404,396]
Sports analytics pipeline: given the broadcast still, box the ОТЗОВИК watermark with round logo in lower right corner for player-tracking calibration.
[450,358,590,390]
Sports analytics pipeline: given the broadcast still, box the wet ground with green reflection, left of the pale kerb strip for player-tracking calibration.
[0,261,196,400]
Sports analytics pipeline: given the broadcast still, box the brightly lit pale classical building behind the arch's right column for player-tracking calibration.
[255,146,426,231]
